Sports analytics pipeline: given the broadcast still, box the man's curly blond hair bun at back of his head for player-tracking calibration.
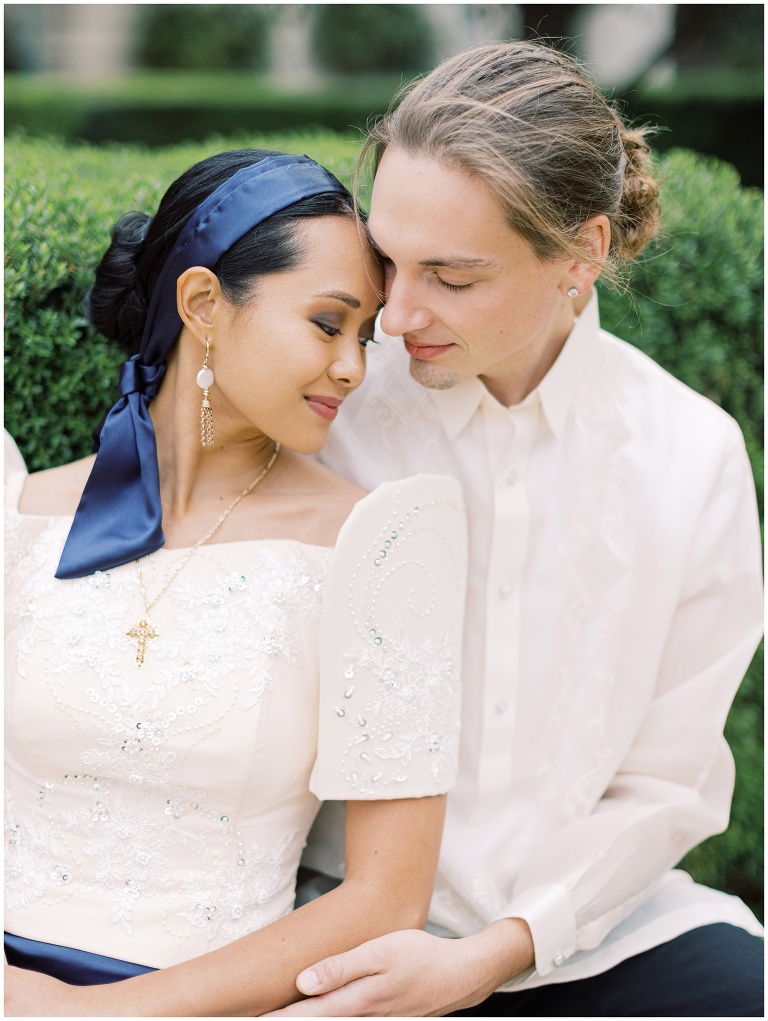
[616,127,660,259]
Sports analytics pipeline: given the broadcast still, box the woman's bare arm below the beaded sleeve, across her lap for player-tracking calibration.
[6,796,445,1017]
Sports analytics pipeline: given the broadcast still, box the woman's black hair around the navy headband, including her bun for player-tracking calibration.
[85,149,355,355]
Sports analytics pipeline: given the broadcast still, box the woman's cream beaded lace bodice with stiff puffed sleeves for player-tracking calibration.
[5,472,466,968]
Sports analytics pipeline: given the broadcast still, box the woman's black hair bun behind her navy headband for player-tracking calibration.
[85,212,152,354]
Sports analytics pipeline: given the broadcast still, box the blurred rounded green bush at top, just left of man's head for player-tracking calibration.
[313,3,433,71]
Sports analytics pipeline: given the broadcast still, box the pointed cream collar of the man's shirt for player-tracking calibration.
[430,289,599,441]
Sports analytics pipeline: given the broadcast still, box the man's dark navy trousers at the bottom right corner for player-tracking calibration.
[450,923,764,1018]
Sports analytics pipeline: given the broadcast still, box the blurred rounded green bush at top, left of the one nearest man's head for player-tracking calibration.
[137,3,272,70]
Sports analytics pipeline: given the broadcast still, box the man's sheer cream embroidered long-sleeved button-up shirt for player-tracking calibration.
[305,295,762,990]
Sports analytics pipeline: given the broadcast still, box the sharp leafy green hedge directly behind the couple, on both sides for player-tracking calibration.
[5,134,763,913]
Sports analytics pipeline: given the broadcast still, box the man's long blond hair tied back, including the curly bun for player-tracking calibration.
[359,42,659,279]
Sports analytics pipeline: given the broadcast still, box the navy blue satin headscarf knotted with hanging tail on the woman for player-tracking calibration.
[56,156,348,578]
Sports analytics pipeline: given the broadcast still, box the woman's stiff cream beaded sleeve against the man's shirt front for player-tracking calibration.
[309,475,467,800]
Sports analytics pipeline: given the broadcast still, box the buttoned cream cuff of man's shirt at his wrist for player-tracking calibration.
[499,883,576,975]
